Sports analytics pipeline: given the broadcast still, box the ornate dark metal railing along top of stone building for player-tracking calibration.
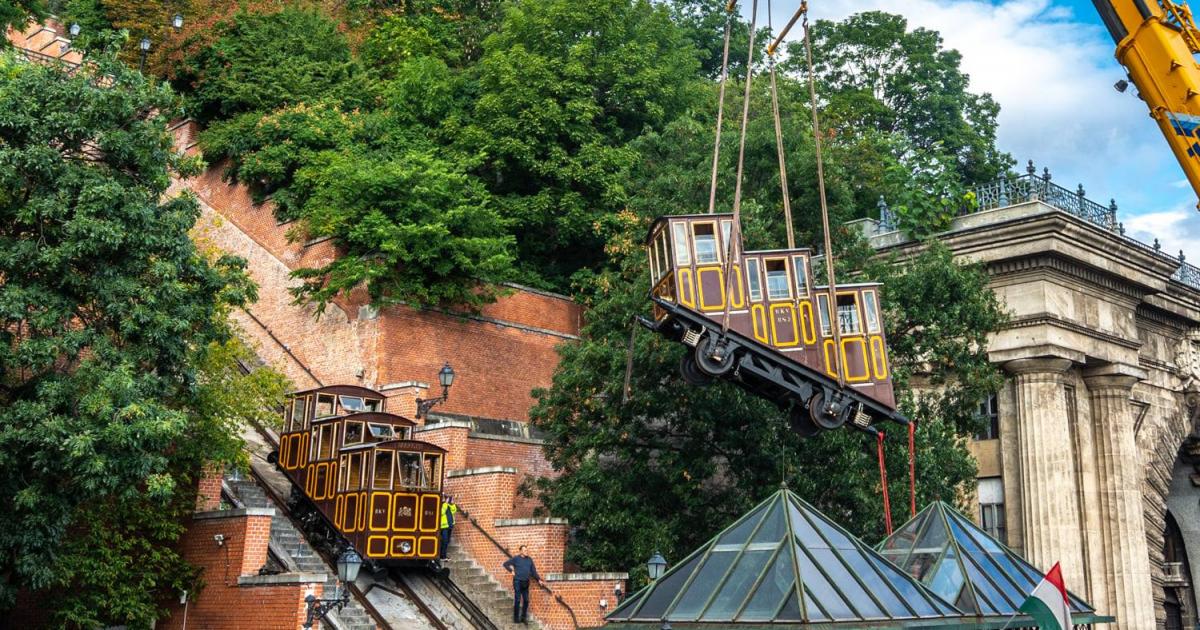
[955,160,1200,289]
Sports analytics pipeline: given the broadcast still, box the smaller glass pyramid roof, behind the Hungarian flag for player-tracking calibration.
[878,502,1100,623]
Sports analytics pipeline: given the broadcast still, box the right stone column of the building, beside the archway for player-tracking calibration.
[1084,366,1154,630]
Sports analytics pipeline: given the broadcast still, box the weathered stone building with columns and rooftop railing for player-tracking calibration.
[859,172,1200,629]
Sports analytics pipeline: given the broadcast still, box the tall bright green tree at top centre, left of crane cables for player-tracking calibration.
[457,0,698,289]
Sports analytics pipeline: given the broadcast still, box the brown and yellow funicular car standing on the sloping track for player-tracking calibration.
[277,385,446,565]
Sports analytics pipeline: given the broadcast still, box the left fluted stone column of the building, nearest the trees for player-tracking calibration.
[1004,358,1085,589]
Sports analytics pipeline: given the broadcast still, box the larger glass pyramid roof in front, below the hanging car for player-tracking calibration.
[607,488,962,628]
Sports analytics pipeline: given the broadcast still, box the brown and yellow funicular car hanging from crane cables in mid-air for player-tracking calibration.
[641,214,907,436]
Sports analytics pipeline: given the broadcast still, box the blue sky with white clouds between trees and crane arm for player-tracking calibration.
[740,0,1200,264]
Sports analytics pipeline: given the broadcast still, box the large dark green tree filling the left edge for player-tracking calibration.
[0,48,277,628]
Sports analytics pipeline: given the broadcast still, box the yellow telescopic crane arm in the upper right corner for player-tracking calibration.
[1092,0,1200,202]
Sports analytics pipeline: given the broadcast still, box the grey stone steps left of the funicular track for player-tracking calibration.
[227,479,376,630]
